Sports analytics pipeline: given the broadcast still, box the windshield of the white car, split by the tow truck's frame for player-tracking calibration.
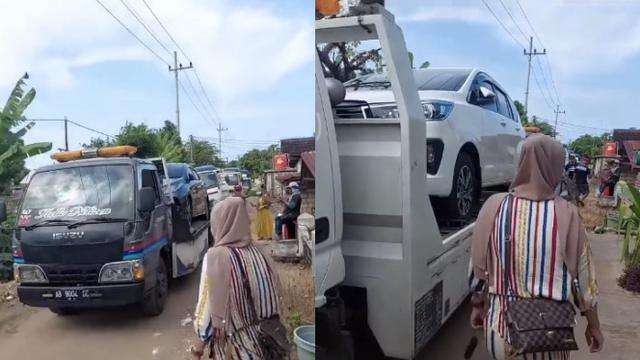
[344,69,471,91]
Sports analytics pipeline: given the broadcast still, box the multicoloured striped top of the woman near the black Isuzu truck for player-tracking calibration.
[194,245,278,360]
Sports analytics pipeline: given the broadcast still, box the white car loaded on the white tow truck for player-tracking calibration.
[336,68,525,220]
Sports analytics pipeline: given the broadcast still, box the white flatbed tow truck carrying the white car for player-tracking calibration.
[314,1,474,359]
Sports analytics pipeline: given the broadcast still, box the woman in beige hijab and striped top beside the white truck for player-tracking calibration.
[471,135,604,359]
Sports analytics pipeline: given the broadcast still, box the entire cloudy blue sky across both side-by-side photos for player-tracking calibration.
[5,0,640,167]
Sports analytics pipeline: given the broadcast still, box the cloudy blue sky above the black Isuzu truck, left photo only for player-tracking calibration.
[0,0,314,168]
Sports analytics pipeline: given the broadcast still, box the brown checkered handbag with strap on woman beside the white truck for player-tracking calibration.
[504,195,578,355]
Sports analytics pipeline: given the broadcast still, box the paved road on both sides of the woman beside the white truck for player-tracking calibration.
[417,234,640,360]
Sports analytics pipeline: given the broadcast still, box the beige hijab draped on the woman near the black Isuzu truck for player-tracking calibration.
[207,196,251,328]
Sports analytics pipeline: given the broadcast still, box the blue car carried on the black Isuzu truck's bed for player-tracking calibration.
[167,163,209,224]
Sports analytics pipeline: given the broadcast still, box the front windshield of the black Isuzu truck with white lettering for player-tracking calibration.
[19,165,134,226]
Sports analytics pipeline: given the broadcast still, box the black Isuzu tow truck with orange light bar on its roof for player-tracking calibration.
[0,146,211,315]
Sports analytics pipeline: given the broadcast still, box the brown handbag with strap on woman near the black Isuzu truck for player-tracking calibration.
[231,248,289,360]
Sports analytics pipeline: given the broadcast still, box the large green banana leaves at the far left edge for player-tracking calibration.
[0,73,52,193]
